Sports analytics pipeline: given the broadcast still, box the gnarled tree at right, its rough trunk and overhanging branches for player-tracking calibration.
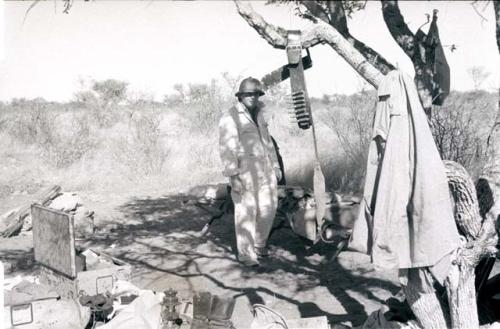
[234,0,500,328]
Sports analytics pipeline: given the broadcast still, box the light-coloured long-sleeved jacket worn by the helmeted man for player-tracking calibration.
[219,103,279,190]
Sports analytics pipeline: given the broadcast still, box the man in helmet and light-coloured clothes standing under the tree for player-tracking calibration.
[219,77,281,266]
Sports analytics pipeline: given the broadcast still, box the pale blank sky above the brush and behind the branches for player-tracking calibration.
[0,0,500,101]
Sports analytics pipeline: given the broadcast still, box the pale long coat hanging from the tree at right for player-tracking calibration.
[350,71,460,269]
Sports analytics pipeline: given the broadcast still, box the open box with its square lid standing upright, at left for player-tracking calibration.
[31,204,132,298]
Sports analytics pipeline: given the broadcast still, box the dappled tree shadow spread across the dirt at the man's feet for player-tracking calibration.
[80,195,399,325]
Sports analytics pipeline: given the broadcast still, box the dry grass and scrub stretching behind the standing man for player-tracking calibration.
[0,83,496,200]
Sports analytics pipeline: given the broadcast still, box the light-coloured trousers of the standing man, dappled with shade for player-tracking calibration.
[231,179,278,259]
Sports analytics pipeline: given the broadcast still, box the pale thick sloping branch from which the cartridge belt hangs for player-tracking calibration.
[234,0,383,88]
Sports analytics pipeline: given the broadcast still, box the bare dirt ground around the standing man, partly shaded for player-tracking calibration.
[0,188,496,328]
